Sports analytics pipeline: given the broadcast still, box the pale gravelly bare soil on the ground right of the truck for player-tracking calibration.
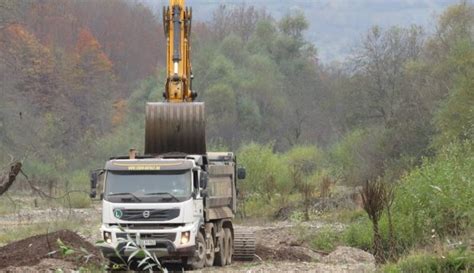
[205,221,376,273]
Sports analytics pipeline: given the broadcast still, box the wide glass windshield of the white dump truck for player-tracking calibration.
[105,171,192,203]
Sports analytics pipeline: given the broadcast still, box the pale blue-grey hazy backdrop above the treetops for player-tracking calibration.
[141,0,459,63]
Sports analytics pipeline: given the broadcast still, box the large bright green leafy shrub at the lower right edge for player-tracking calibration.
[394,141,474,238]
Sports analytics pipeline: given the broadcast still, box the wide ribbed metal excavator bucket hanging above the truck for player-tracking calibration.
[145,102,206,155]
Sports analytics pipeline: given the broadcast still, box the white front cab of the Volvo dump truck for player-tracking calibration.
[97,157,206,256]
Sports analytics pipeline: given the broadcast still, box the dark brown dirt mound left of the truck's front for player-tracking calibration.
[0,230,100,269]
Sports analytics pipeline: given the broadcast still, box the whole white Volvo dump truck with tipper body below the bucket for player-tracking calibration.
[91,153,252,268]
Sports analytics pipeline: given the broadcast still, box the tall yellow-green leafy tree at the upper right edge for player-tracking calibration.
[430,2,474,148]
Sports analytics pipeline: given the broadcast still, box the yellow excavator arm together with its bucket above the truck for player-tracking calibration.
[145,0,206,155]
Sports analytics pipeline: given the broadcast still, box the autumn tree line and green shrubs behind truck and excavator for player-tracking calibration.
[0,0,474,264]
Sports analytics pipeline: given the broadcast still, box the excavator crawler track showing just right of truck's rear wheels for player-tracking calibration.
[233,228,256,261]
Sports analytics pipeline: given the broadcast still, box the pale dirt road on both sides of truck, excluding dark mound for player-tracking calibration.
[0,207,375,273]
